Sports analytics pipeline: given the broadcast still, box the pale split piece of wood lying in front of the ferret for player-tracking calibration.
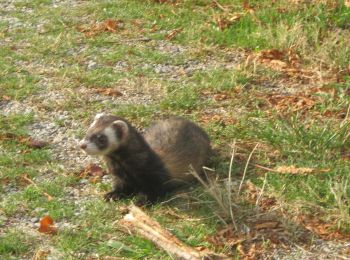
[119,205,230,260]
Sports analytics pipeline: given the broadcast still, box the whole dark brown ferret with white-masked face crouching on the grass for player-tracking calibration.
[79,113,211,203]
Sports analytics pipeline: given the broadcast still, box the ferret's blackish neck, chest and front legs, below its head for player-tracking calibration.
[105,128,174,203]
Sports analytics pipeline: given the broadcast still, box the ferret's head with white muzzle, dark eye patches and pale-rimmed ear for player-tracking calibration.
[79,113,129,155]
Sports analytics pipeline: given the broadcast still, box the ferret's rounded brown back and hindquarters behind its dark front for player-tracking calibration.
[144,117,211,186]
